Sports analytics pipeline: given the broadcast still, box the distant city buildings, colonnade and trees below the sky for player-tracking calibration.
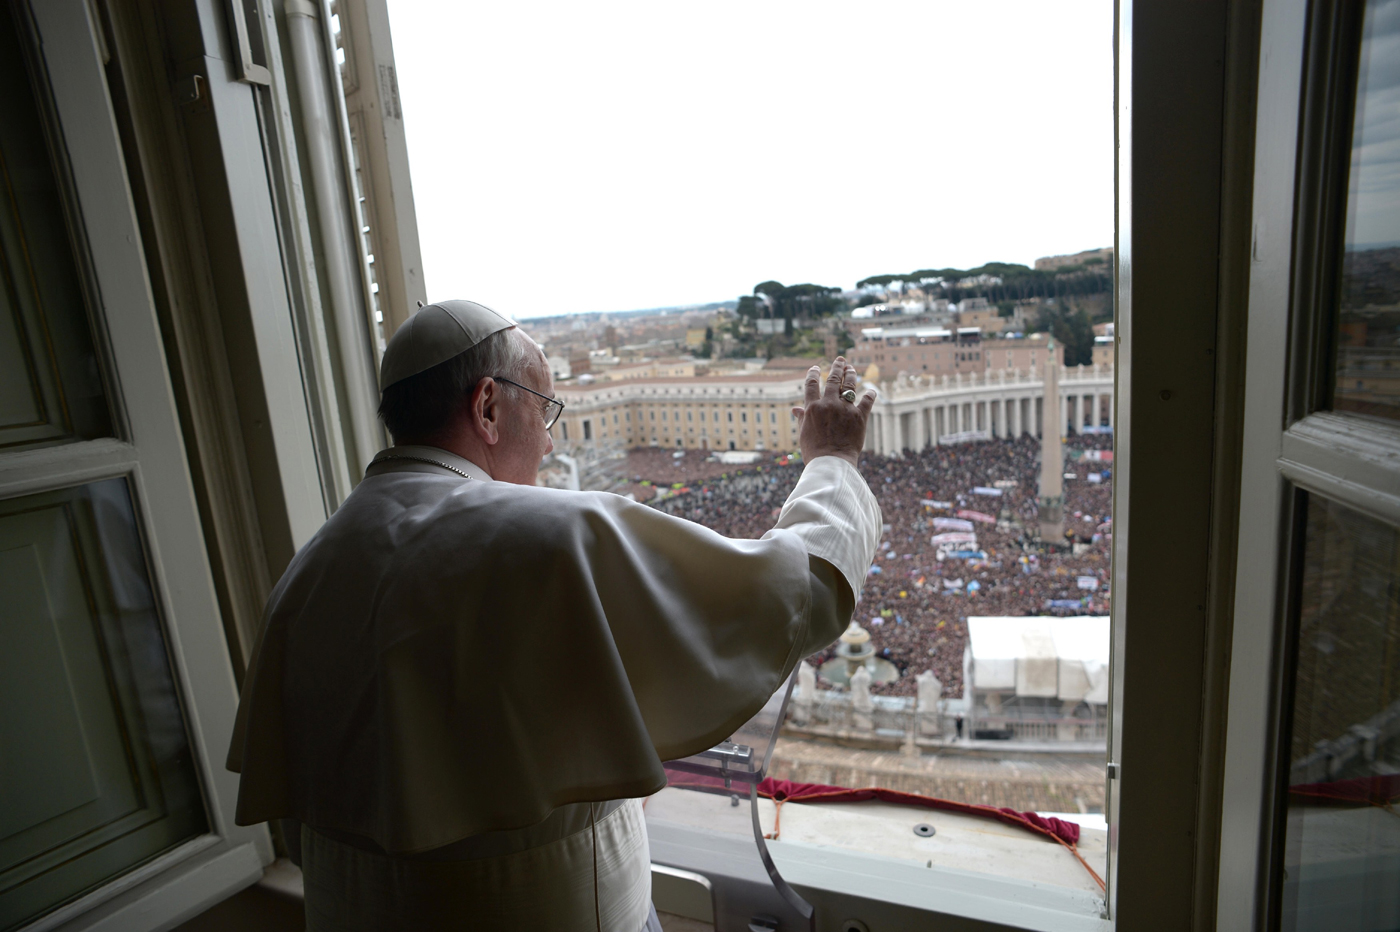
[525,249,1113,487]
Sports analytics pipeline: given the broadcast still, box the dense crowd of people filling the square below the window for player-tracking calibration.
[651,434,1113,697]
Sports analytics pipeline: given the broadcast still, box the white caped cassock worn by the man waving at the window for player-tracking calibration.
[228,446,881,932]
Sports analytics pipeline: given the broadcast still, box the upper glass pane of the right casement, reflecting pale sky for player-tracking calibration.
[1333,0,1400,418]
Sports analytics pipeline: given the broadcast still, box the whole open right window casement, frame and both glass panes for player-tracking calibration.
[1221,0,1400,932]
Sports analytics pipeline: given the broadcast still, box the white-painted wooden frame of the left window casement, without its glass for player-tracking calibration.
[0,0,273,932]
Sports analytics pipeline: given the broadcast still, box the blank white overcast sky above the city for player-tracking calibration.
[389,0,1113,318]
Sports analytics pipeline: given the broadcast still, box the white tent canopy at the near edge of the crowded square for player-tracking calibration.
[967,616,1109,705]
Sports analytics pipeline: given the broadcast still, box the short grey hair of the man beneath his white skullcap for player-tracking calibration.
[379,327,538,444]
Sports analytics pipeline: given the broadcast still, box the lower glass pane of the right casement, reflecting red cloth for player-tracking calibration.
[1282,497,1400,932]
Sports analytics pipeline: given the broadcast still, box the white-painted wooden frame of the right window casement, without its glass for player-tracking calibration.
[1215,0,1400,929]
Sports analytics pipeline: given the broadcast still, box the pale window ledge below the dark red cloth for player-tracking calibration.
[647,789,1112,932]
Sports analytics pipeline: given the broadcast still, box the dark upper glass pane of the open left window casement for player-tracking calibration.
[0,4,112,449]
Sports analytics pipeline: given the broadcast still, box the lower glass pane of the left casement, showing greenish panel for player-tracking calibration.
[0,479,207,929]
